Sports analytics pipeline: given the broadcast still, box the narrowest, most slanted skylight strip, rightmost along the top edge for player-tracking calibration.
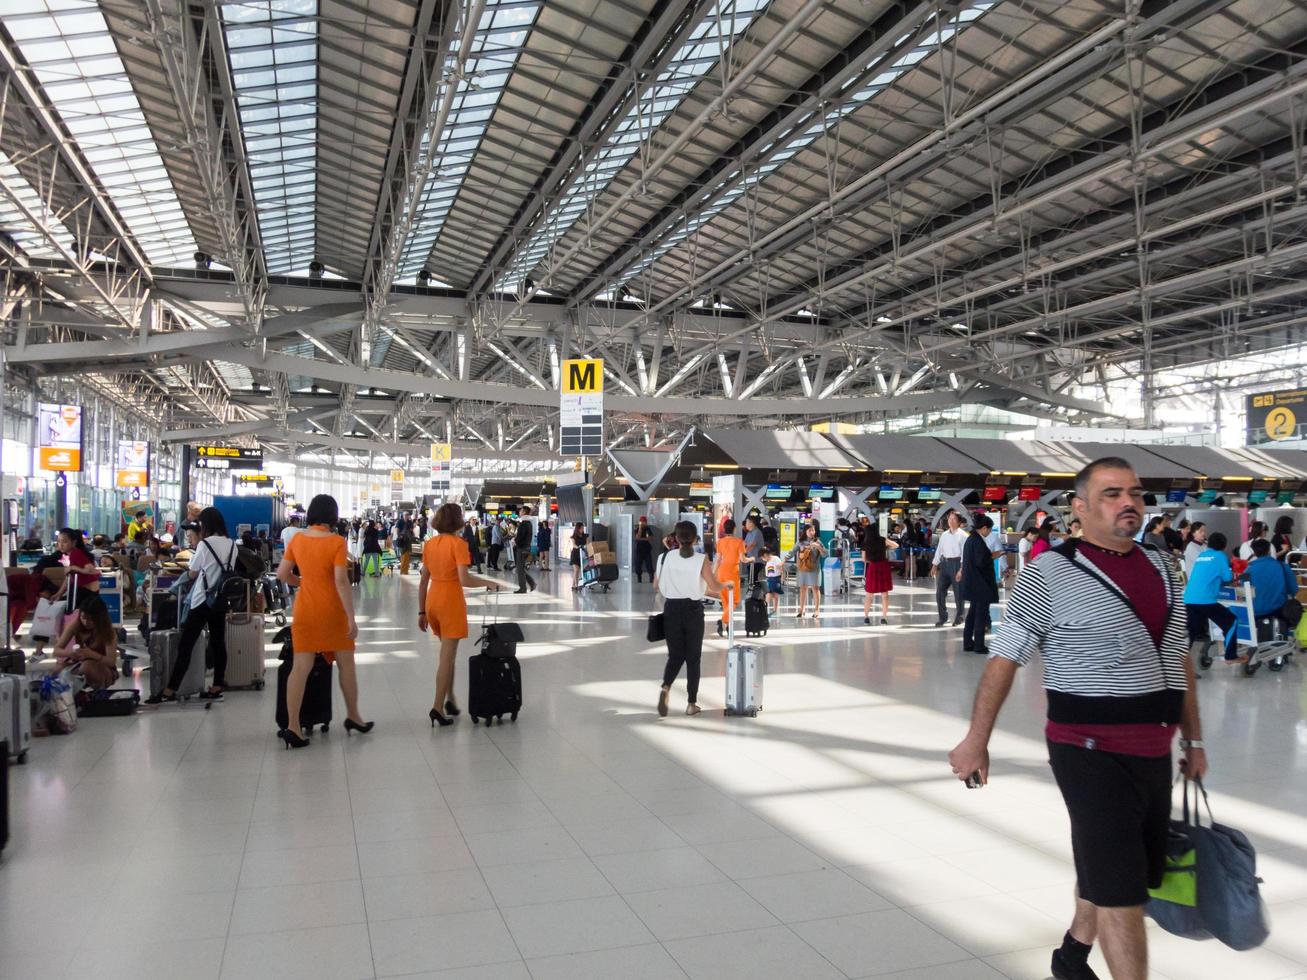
[617,0,997,291]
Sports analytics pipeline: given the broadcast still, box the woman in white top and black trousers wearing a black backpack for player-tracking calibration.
[145,507,237,704]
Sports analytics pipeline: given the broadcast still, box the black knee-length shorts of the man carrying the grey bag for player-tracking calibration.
[1048,742,1171,908]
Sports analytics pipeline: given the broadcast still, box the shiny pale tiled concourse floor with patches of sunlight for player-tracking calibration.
[0,576,1307,980]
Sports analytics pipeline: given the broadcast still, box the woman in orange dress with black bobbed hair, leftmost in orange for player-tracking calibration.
[277,494,372,749]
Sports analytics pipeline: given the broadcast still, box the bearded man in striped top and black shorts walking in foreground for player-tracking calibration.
[949,457,1208,980]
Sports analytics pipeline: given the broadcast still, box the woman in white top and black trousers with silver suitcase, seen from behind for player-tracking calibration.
[654,520,721,717]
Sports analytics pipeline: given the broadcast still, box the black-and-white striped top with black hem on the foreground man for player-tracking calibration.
[989,541,1189,725]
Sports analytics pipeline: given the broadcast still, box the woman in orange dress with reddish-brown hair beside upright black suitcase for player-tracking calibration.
[417,503,499,728]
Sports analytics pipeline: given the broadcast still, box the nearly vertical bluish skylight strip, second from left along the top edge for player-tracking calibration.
[222,0,318,274]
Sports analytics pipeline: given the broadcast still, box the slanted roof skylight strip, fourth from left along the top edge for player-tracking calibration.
[495,0,770,290]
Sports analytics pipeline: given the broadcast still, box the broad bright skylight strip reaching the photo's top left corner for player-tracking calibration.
[0,0,195,265]
